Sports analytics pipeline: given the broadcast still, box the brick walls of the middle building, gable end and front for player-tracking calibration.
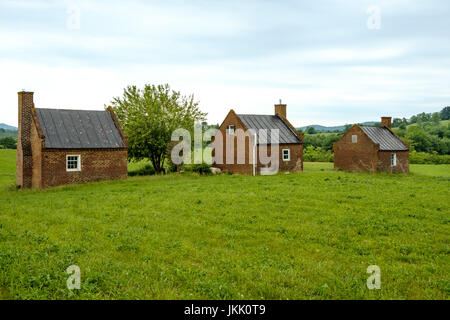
[213,110,303,174]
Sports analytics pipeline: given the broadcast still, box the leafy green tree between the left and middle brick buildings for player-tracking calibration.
[111,84,206,173]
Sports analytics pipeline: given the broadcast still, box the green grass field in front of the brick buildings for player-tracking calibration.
[0,150,450,299]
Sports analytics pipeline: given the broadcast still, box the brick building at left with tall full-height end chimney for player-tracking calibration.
[17,92,127,188]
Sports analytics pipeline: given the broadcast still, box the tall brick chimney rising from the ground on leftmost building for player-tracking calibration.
[16,91,34,188]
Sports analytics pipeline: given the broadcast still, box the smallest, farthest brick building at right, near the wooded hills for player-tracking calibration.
[333,117,409,173]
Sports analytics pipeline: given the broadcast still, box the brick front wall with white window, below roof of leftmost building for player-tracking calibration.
[41,149,127,188]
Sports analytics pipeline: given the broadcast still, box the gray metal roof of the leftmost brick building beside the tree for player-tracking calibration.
[35,108,126,149]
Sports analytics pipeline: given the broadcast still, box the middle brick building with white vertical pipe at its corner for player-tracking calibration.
[212,103,303,175]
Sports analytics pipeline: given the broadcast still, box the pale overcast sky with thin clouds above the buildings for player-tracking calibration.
[0,0,450,126]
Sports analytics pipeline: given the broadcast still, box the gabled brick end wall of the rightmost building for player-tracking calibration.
[333,126,378,172]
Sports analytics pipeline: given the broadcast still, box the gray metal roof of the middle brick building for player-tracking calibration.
[237,114,302,144]
